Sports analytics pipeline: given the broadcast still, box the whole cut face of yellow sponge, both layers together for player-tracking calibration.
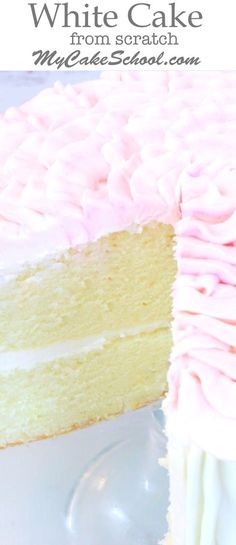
[0,224,176,446]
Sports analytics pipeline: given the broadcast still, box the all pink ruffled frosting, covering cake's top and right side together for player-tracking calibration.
[0,72,236,458]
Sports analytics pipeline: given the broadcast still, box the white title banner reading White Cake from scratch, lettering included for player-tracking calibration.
[0,0,236,71]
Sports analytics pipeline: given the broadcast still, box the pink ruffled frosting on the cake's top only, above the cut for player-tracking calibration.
[0,72,236,271]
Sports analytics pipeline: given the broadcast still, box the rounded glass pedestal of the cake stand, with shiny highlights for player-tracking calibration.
[66,404,168,545]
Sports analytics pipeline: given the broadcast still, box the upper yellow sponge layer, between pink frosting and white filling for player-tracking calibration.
[0,224,175,350]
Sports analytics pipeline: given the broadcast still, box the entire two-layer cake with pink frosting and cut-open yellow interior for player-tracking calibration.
[0,72,236,545]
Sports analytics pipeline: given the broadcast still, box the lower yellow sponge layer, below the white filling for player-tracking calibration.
[0,328,171,446]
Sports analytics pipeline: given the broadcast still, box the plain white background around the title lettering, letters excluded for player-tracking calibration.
[0,0,236,71]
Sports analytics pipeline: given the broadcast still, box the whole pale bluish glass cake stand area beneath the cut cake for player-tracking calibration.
[0,406,168,545]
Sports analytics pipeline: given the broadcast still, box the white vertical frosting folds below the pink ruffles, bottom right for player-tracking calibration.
[170,441,236,545]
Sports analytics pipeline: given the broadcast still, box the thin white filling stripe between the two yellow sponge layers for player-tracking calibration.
[0,320,170,372]
